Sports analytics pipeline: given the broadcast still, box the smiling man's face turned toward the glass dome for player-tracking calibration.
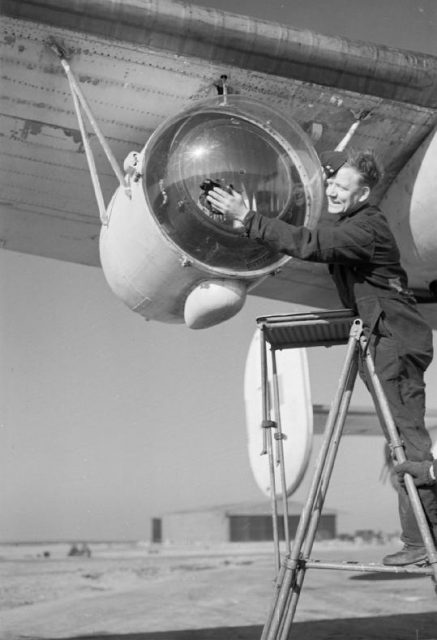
[326,165,370,215]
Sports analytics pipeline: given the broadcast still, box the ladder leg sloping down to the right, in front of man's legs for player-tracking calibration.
[360,335,437,584]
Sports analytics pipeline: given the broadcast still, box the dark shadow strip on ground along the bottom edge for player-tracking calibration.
[46,612,437,640]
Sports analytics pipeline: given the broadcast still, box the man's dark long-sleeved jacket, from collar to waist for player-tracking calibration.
[244,204,432,367]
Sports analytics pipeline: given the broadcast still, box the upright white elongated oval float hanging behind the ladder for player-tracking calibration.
[244,330,313,496]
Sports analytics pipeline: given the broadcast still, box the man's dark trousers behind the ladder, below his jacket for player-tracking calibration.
[360,323,437,546]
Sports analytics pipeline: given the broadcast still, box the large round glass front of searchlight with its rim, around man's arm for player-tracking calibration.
[144,98,323,274]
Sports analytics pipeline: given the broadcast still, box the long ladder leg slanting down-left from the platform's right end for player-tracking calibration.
[261,320,362,640]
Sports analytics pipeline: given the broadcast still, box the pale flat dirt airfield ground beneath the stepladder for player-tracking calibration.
[0,541,437,640]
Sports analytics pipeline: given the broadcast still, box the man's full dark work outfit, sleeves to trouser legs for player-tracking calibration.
[244,204,437,546]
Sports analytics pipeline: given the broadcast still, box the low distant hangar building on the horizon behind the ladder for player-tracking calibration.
[152,500,337,544]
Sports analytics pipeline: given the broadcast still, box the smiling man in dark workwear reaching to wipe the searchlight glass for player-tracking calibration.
[208,151,437,565]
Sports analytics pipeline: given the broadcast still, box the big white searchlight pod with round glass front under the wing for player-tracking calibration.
[100,96,323,327]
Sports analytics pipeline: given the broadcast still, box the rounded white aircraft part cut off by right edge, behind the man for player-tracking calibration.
[381,131,437,290]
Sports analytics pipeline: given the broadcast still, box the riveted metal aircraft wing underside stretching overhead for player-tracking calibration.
[0,0,437,307]
